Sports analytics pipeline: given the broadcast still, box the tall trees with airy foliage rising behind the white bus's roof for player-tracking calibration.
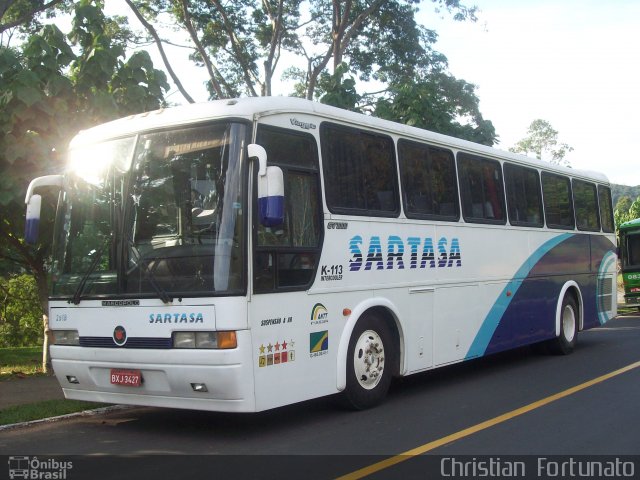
[126,0,496,145]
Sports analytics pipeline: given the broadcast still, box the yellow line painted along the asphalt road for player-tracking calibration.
[337,361,640,480]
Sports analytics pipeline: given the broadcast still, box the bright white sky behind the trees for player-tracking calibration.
[107,0,640,185]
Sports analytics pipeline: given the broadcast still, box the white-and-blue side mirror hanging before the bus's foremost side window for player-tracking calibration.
[248,143,284,227]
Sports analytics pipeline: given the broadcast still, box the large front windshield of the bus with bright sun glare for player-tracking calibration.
[51,123,246,303]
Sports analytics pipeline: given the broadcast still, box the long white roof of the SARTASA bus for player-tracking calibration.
[71,97,608,183]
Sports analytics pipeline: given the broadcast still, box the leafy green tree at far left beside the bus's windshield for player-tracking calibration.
[0,0,169,370]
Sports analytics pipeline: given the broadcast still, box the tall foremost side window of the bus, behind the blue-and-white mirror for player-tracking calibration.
[254,125,322,293]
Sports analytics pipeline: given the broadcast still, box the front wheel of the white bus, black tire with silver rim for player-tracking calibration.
[344,313,395,410]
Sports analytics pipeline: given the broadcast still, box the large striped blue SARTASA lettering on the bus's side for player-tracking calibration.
[349,235,462,272]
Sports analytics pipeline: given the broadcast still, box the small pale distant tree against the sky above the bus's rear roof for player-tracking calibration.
[509,119,573,166]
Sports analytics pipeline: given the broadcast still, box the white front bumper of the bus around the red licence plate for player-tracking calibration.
[51,330,255,412]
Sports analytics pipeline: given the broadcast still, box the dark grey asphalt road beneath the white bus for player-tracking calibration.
[0,316,640,478]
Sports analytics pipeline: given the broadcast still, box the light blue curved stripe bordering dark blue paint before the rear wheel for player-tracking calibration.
[465,233,573,360]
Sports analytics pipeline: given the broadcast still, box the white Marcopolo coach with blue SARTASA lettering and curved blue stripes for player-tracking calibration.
[26,98,616,412]
